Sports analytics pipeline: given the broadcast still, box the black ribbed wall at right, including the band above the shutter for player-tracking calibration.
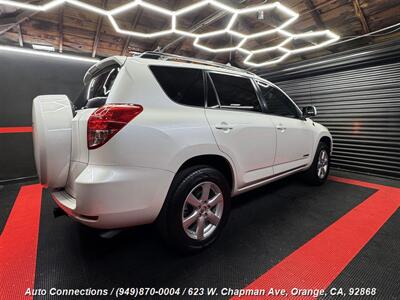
[263,42,400,178]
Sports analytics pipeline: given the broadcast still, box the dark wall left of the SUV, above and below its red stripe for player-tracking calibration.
[0,52,91,182]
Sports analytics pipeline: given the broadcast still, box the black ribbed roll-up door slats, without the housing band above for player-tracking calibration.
[276,63,400,178]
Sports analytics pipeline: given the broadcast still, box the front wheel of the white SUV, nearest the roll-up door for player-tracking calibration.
[304,142,330,185]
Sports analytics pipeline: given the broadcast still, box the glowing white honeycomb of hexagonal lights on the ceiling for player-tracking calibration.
[0,0,340,67]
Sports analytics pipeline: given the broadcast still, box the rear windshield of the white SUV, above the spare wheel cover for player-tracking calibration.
[74,65,120,109]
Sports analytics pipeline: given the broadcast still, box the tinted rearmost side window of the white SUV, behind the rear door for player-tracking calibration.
[150,66,204,107]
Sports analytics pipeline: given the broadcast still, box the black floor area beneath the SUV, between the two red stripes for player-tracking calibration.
[37,176,360,288]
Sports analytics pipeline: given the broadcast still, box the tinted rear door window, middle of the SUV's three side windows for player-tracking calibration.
[210,73,261,112]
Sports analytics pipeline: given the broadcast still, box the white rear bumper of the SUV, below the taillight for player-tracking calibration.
[52,165,174,229]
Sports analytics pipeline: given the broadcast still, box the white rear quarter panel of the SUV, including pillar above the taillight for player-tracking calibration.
[89,60,233,177]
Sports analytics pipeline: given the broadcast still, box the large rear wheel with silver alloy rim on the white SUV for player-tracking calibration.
[156,166,231,253]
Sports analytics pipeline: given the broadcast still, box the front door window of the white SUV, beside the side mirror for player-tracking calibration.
[258,82,298,118]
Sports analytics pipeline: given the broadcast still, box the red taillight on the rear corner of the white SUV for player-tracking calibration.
[87,104,143,149]
